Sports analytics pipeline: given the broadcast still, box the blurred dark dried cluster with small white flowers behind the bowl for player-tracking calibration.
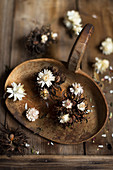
[26,26,58,55]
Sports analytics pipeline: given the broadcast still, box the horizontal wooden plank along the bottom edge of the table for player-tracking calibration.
[0,155,113,170]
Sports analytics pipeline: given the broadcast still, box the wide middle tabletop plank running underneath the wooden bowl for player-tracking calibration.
[7,0,84,155]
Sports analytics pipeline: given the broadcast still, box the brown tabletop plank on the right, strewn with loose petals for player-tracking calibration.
[78,0,113,155]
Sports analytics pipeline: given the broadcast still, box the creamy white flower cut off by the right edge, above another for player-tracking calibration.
[100,37,113,55]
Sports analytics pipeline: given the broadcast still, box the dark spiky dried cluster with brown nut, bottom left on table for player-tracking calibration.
[0,125,28,156]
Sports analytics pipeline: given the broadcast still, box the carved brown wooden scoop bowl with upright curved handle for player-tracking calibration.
[5,24,108,144]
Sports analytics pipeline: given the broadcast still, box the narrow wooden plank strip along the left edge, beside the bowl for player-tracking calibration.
[0,0,14,124]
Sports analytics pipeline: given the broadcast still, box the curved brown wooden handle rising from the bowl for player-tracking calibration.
[68,24,94,72]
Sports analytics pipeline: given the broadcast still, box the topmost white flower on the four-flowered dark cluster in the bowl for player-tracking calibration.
[70,82,83,95]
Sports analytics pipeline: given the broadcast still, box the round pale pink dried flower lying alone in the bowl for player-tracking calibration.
[26,108,39,122]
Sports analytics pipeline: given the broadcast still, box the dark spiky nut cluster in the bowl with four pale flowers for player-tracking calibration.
[56,82,89,126]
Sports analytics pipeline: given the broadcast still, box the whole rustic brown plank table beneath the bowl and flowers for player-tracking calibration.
[0,0,113,170]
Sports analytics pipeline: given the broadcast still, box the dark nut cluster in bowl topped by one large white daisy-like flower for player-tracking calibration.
[36,66,66,100]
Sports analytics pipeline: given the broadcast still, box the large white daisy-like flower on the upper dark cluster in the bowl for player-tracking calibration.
[37,69,55,87]
